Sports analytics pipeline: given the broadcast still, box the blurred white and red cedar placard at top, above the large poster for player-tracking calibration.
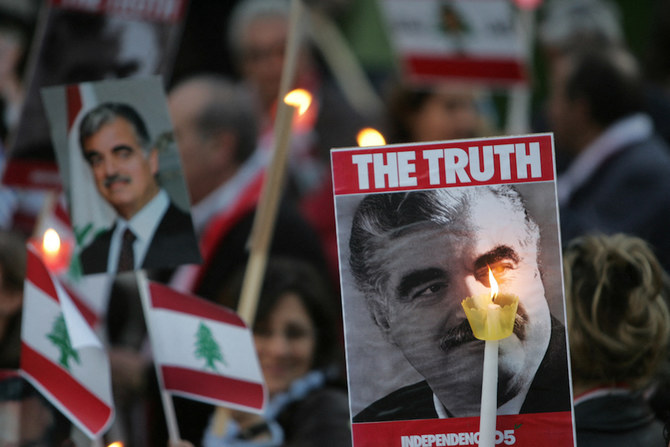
[379,0,528,85]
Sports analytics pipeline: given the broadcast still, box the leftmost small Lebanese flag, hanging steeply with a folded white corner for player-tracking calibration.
[21,248,114,439]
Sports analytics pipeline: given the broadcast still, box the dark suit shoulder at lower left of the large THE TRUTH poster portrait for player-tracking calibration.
[354,380,437,422]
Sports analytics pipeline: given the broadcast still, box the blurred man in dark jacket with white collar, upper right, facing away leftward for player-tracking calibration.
[549,47,670,269]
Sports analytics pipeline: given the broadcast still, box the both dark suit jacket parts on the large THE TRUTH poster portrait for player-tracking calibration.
[353,317,570,422]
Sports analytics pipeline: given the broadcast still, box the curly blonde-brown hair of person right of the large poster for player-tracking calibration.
[564,234,670,388]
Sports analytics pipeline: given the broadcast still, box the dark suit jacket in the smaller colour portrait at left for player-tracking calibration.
[79,203,200,274]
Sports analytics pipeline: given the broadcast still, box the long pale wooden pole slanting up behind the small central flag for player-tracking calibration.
[212,0,304,437]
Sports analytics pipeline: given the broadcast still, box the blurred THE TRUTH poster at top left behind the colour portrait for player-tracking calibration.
[2,0,188,189]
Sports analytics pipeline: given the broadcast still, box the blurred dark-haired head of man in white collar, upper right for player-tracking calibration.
[564,46,644,128]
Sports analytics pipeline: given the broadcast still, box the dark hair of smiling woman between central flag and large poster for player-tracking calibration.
[221,257,339,369]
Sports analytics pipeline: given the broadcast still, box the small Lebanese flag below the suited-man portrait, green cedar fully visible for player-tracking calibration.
[147,282,267,413]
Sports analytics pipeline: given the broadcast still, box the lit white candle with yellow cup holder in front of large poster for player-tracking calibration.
[461,268,519,447]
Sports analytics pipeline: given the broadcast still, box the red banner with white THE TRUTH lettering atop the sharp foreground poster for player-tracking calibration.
[332,134,554,194]
